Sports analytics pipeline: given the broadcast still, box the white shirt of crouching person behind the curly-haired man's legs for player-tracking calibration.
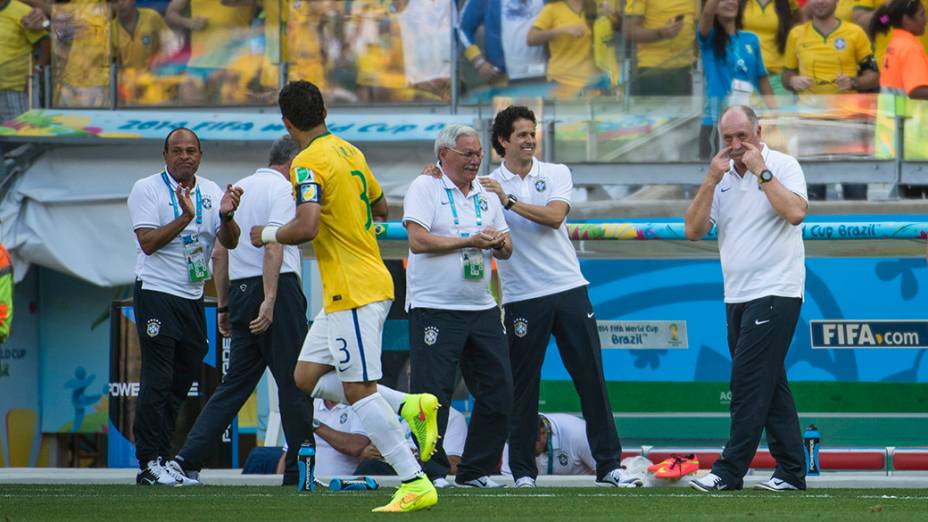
[500,413,596,478]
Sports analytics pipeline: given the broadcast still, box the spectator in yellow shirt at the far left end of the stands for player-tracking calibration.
[0,0,49,124]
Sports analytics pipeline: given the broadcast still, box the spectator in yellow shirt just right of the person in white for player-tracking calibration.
[526,0,602,98]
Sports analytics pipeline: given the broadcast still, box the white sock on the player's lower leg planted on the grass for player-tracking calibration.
[354,390,422,481]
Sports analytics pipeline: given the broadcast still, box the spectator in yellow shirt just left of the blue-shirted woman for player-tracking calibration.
[625,0,699,96]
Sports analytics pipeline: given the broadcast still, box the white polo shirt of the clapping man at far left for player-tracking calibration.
[128,172,223,299]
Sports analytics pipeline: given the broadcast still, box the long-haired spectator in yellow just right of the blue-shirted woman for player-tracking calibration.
[741,0,799,95]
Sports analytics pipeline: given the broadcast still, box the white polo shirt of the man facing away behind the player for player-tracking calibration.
[229,168,300,279]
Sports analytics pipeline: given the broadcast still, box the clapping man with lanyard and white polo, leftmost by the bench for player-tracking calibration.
[128,128,242,485]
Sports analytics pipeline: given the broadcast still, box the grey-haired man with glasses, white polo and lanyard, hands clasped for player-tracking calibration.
[403,125,512,487]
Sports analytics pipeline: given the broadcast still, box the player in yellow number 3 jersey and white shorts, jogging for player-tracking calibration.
[251,80,439,512]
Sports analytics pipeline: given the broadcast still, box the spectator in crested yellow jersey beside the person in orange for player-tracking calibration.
[783,0,879,97]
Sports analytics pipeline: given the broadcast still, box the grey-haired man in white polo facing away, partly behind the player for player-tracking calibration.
[175,136,312,484]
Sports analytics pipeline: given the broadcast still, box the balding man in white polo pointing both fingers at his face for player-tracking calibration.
[686,106,808,492]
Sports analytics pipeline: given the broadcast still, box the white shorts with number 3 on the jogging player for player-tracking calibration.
[299,301,393,382]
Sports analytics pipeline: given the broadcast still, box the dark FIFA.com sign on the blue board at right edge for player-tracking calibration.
[809,321,928,348]
